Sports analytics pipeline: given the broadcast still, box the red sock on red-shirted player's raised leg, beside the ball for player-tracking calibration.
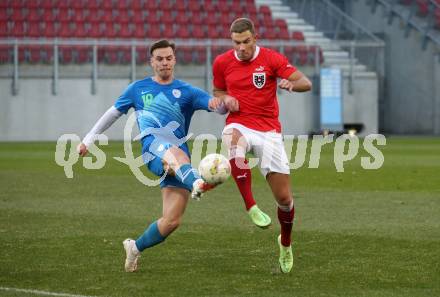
[229,158,256,210]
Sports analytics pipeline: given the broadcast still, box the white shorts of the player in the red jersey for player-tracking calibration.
[223,123,290,177]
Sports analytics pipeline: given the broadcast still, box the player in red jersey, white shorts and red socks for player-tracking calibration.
[213,18,312,273]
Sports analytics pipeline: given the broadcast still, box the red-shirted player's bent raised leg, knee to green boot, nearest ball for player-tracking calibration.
[222,129,271,228]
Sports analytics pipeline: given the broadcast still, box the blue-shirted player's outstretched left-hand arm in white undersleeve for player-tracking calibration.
[76,106,122,157]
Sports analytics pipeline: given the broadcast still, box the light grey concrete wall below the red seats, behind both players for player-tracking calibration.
[0,66,378,141]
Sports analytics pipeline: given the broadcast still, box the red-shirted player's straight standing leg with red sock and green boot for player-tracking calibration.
[266,172,295,273]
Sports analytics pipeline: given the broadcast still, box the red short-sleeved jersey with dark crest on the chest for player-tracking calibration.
[212,46,296,133]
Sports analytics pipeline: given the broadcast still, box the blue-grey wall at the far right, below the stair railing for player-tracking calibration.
[349,0,440,134]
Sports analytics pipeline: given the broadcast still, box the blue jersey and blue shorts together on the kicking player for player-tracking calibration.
[115,77,211,190]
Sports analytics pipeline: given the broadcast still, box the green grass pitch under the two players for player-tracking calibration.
[0,137,440,297]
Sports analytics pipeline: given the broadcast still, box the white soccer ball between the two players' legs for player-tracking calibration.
[199,154,231,185]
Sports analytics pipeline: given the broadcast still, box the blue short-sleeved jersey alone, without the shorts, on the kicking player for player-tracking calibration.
[115,77,211,139]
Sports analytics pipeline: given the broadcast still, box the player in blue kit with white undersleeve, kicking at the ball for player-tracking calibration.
[78,40,234,272]
